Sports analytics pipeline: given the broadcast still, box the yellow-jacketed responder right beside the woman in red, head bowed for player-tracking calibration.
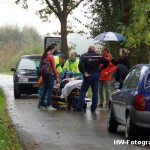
[54,54,66,79]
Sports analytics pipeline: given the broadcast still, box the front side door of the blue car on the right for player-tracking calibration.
[112,69,135,123]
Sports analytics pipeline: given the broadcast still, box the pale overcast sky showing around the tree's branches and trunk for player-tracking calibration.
[0,0,92,54]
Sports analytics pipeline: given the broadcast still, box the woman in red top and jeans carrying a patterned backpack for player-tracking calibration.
[39,45,58,110]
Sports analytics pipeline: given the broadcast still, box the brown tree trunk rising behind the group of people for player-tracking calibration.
[60,15,68,56]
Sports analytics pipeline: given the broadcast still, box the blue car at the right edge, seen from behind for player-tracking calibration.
[108,64,150,139]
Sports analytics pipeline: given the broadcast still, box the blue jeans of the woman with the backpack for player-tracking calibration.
[40,75,55,106]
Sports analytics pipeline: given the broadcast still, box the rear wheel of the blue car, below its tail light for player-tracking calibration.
[125,114,137,140]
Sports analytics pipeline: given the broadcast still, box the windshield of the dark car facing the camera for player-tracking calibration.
[18,58,40,70]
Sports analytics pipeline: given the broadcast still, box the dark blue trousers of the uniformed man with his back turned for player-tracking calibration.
[77,73,99,112]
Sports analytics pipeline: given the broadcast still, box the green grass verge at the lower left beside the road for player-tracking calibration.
[0,89,22,150]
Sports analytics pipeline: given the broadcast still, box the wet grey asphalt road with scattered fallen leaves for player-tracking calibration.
[0,75,150,150]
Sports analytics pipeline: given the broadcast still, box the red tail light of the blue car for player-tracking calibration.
[134,94,146,110]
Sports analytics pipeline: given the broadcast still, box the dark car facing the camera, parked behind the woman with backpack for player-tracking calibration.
[11,54,41,99]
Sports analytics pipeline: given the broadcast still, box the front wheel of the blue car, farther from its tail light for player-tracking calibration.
[107,108,118,133]
